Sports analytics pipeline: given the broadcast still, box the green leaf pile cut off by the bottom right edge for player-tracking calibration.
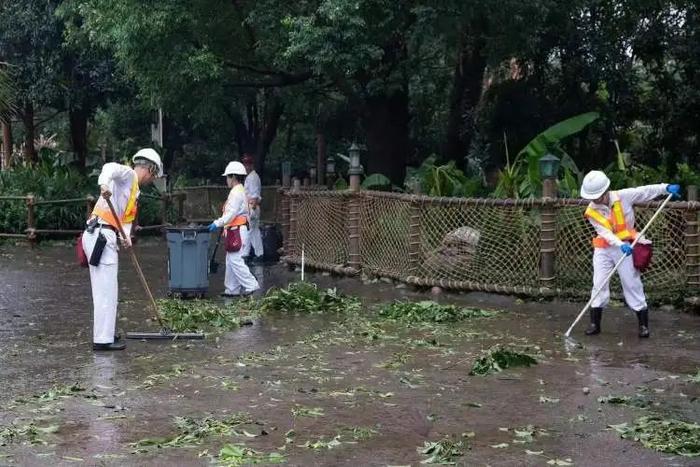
[610,416,700,457]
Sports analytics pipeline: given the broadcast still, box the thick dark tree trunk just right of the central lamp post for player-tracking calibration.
[363,90,410,186]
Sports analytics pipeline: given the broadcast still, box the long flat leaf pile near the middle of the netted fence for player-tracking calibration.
[379,300,497,323]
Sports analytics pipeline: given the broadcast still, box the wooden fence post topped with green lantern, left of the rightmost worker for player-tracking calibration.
[539,154,559,287]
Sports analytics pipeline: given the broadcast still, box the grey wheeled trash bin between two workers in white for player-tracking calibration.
[166,226,210,298]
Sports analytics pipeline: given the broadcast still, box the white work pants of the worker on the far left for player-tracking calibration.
[83,227,119,344]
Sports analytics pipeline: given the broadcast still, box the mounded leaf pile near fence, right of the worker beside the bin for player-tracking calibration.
[260,282,360,313]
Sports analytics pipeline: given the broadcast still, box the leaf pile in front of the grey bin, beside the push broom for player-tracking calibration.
[158,299,241,332]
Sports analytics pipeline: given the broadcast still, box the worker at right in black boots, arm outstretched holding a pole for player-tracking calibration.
[581,170,680,337]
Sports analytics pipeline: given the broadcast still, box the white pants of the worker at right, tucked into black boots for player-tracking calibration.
[591,247,647,311]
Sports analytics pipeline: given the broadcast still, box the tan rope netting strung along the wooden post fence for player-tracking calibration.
[285,191,698,296]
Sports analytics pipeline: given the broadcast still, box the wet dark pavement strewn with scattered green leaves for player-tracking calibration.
[0,240,700,466]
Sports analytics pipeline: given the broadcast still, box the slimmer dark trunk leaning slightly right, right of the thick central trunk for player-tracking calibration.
[443,22,486,166]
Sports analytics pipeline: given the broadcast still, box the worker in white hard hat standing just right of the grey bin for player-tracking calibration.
[209,162,260,297]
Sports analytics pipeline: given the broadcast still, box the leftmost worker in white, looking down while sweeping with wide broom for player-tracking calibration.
[82,148,163,350]
